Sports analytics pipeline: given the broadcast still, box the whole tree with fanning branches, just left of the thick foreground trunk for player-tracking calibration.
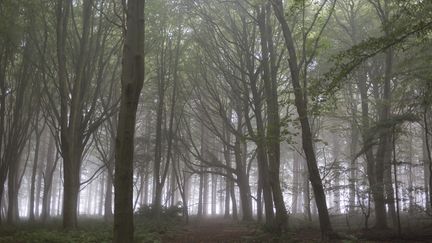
[48,0,118,229]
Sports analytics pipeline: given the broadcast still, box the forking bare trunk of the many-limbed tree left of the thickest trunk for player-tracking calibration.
[56,0,93,229]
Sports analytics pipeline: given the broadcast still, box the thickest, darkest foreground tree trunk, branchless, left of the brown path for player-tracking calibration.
[113,0,145,239]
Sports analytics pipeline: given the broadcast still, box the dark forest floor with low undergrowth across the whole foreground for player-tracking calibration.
[0,217,432,243]
